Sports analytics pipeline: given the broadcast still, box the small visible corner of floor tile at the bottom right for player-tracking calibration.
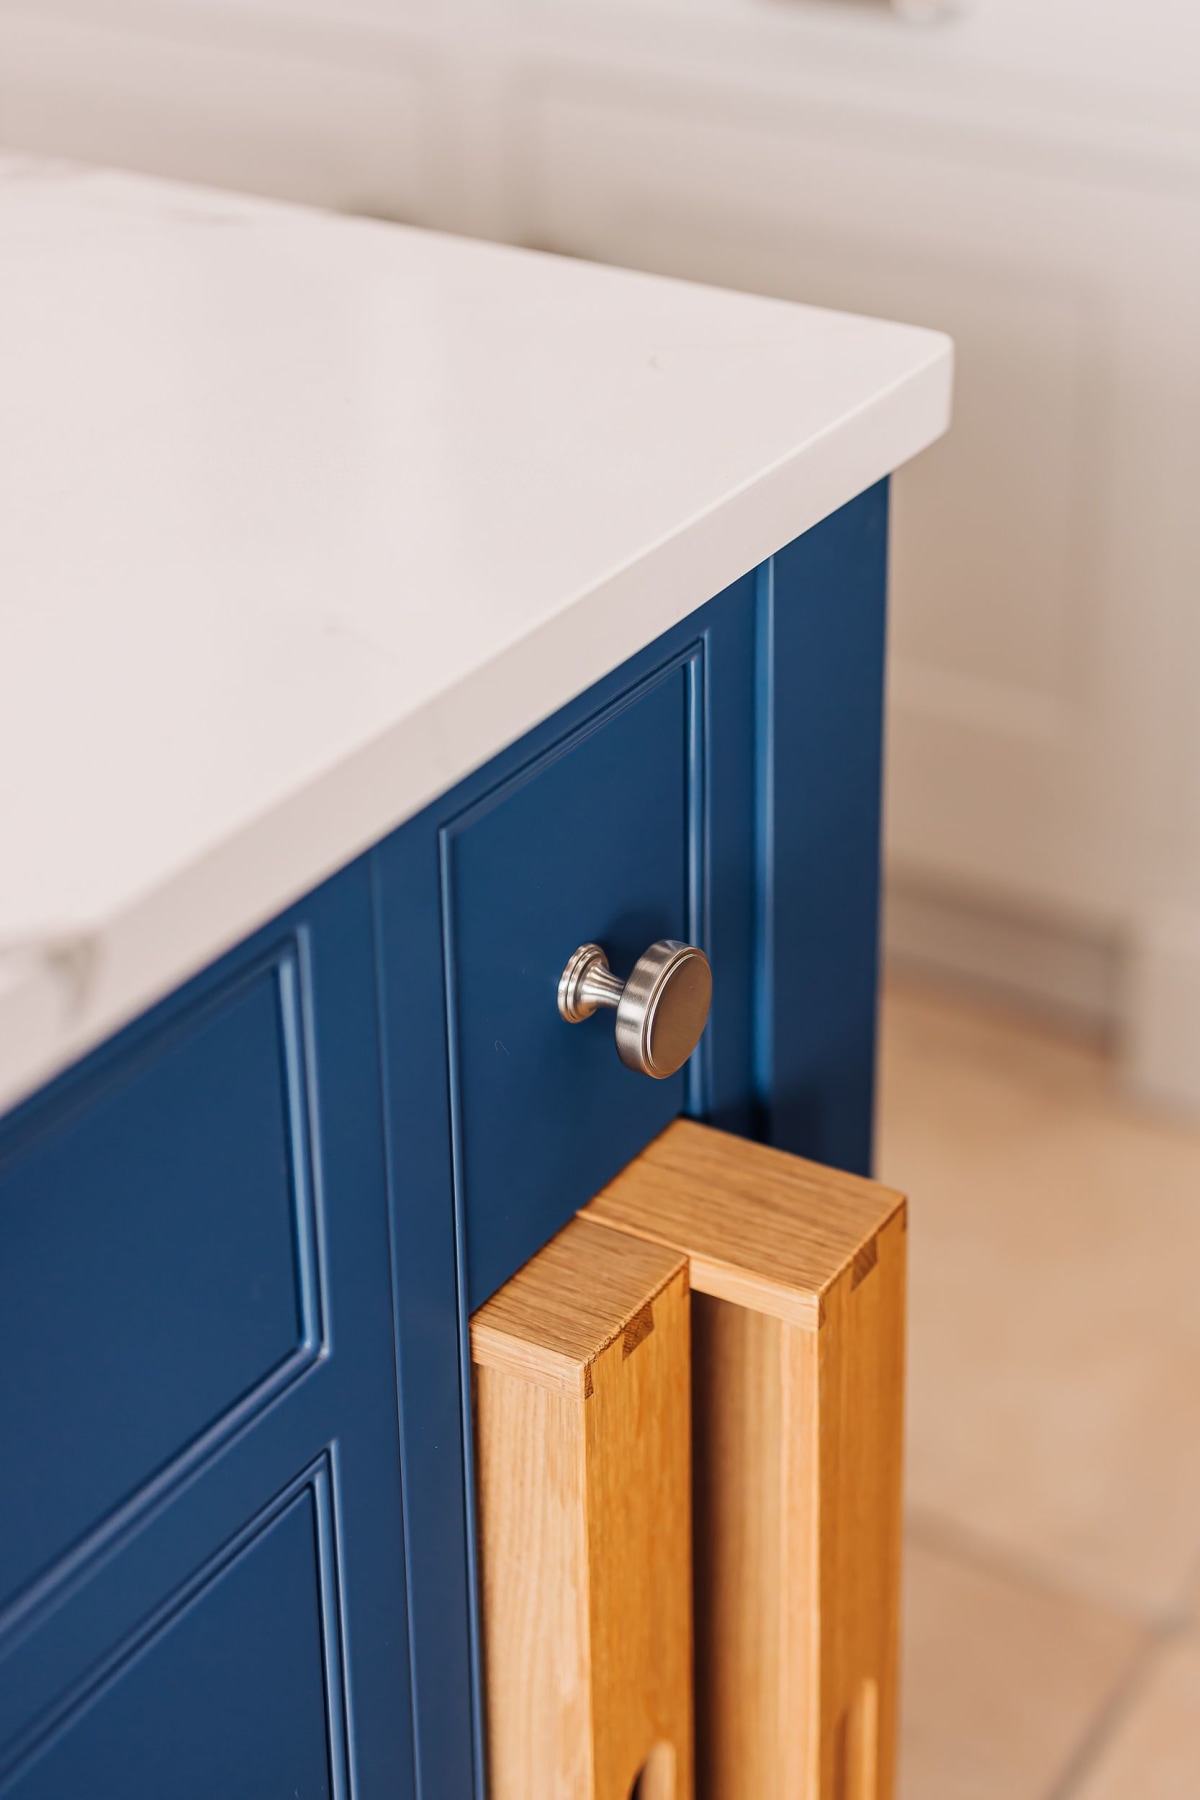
[1072,1636,1200,1800]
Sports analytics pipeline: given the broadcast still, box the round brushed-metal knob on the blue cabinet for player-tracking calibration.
[558,938,712,1082]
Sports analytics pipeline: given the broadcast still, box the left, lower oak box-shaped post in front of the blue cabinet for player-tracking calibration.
[471,1220,693,1800]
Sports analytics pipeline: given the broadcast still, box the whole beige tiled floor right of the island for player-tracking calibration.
[880,986,1200,1800]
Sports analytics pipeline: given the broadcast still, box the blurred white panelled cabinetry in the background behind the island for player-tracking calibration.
[0,0,1200,1105]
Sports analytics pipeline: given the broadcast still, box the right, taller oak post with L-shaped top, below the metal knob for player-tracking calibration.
[581,1120,907,1800]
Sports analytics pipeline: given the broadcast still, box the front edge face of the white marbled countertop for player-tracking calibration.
[0,333,954,1114]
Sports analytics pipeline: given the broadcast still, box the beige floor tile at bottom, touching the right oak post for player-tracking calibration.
[900,1546,1142,1800]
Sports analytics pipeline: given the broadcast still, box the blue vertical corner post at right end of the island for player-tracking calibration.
[756,482,887,1174]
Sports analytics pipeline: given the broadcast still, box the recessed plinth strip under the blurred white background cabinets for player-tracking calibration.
[883,877,1124,1039]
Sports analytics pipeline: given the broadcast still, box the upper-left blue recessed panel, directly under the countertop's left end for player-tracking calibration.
[0,949,318,1615]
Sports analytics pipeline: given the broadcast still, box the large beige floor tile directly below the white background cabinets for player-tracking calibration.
[878,990,1200,1620]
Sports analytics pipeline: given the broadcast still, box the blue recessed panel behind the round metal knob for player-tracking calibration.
[441,657,700,1310]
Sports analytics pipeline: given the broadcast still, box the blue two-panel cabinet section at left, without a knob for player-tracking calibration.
[0,864,412,1800]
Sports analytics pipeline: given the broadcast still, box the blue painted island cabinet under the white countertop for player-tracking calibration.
[0,486,887,1800]
